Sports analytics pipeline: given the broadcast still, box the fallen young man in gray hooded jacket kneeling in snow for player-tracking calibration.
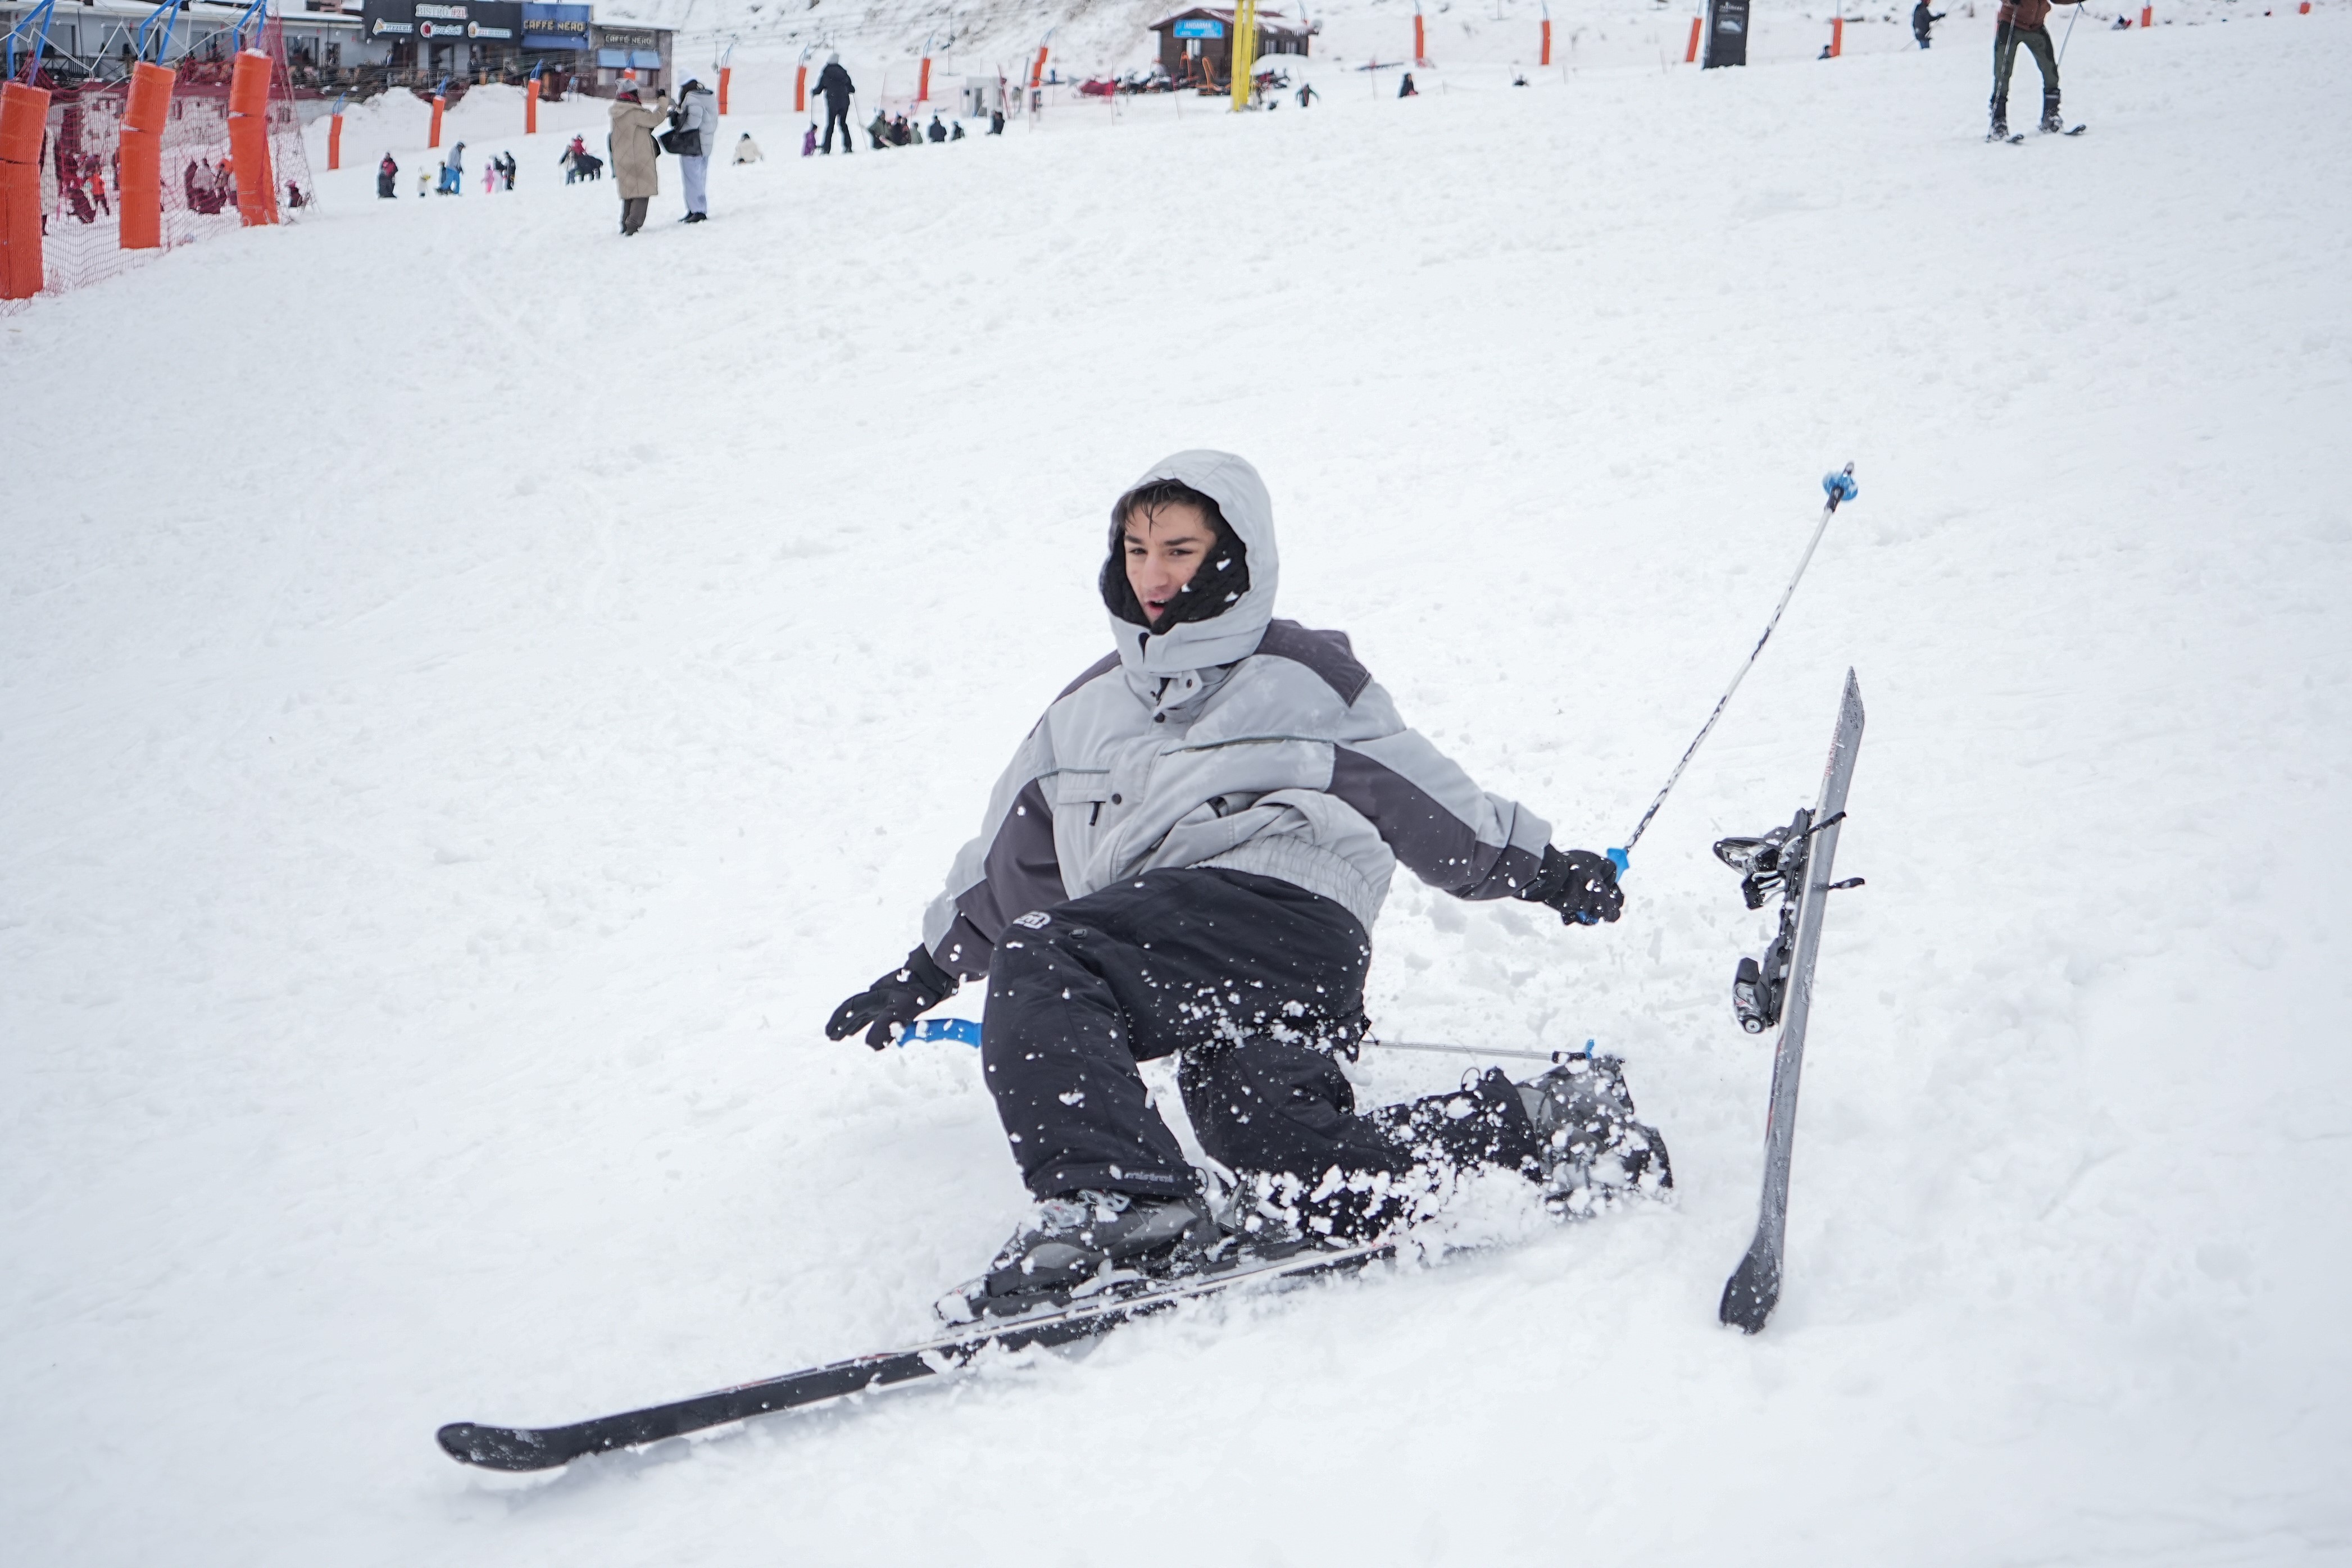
[825,451,1672,1319]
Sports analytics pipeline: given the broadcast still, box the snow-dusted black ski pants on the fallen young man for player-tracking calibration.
[981,867,1541,1234]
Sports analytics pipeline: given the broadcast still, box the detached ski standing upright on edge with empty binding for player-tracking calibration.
[1715,670,1863,1333]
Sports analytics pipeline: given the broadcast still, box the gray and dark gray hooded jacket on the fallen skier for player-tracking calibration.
[922,451,1552,978]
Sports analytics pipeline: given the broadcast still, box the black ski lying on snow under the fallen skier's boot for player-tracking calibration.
[435,1241,1397,1469]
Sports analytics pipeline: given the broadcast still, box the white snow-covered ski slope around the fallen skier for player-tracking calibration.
[0,7,2352,1568]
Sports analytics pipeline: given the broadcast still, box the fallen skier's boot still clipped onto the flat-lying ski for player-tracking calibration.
[938,1189,1218,1324]
